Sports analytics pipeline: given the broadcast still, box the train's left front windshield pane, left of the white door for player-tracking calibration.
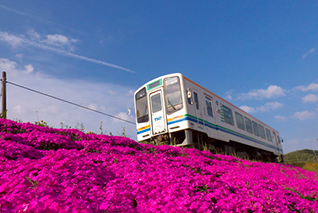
[135,87,149,123]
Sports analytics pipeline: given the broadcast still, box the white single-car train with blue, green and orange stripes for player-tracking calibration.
[134,73,283,161]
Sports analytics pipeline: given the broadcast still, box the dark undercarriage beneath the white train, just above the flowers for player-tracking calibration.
[150,129,283,162]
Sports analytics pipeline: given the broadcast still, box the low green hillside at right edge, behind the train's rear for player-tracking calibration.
[284,149,318,164]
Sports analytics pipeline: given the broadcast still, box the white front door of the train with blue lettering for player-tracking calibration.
[149,90,167,135]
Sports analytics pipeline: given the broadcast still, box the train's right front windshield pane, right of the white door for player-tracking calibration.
[164,77,183,114]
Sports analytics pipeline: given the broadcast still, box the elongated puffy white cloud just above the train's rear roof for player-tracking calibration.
[238,85,285,100]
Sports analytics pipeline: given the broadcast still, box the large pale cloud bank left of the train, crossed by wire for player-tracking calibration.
[0,59,136,139]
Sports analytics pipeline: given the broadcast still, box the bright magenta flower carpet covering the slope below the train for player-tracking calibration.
[0,119,318,213]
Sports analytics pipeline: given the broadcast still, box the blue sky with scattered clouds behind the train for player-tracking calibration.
[0,0,318,153]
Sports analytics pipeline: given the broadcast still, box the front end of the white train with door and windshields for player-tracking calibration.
[134,74,184,144]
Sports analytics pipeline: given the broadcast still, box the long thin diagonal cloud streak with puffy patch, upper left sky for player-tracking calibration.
[0,31,135,73]
